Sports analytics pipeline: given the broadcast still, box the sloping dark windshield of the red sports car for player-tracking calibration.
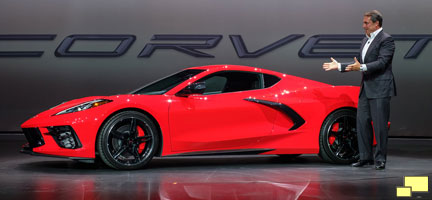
[132,69,204,95]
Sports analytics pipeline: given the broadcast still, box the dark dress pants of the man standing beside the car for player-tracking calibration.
[357,90,391,162]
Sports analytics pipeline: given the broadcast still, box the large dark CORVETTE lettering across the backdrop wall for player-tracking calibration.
[0,34,432,59]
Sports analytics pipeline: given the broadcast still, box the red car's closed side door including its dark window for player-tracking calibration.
[169,71,277,151]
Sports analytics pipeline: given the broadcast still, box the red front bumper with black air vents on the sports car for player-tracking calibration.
[21,101,109,159]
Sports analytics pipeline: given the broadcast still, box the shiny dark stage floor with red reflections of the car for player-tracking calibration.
[0,134,432,200]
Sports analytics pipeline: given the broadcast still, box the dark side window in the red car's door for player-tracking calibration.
[198,71,264,94]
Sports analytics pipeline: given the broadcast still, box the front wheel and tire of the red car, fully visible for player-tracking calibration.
[97,111,159,170]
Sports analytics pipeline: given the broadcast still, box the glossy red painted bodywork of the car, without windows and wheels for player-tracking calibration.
[22,65,359,162]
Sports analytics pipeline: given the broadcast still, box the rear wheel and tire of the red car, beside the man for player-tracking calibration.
[319,109,359,164]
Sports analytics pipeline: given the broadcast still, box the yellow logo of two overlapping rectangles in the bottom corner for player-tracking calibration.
[396,176,429,197]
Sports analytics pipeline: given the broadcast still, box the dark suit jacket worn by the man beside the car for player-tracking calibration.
[341,31,396,99]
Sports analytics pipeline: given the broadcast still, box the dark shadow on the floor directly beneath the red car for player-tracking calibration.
[16,156,332,174]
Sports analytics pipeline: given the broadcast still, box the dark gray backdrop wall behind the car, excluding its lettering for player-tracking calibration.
[0,0,432,137]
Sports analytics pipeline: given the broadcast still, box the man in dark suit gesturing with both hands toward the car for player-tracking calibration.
[323,10,396,170]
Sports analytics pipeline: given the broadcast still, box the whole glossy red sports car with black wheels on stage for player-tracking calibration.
[22,65,359,169]
